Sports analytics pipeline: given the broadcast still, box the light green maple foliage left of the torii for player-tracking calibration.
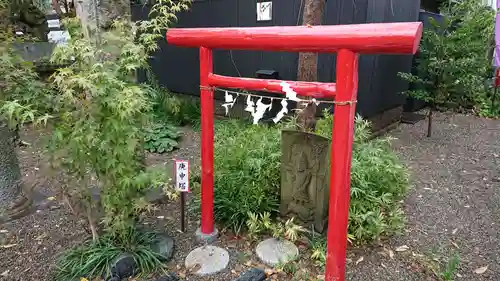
[45,0,189,235]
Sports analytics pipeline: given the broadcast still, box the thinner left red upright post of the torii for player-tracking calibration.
[200,47,215,235]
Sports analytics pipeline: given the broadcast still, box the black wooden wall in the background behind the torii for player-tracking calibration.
[132,0,420,117]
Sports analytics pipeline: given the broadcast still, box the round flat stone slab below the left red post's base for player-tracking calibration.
[185,245,229,276]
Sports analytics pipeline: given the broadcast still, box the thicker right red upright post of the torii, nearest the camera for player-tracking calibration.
[325,49,358,281]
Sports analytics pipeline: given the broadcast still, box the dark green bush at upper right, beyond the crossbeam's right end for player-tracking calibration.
[400,0,495,114]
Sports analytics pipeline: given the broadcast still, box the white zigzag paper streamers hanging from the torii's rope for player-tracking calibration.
[222,81,320,124]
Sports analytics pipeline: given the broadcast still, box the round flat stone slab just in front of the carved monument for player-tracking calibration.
[255,238,299,266]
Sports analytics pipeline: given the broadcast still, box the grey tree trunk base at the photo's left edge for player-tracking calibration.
[0,122,31,221]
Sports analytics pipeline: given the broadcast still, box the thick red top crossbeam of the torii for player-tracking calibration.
[167,22,422,54]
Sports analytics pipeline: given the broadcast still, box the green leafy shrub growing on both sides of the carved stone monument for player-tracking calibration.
[194,113,409,243]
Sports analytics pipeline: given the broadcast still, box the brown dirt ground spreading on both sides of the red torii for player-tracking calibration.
[0,110,500,281]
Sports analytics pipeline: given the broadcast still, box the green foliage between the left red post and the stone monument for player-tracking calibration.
[190,120,281,232]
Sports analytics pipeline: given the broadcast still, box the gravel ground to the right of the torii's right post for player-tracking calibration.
[349,113,500,281]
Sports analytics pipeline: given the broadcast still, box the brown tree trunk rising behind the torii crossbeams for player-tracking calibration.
[297,0,325,131]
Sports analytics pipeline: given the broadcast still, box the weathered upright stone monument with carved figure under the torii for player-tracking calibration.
[280,130,330,232]
